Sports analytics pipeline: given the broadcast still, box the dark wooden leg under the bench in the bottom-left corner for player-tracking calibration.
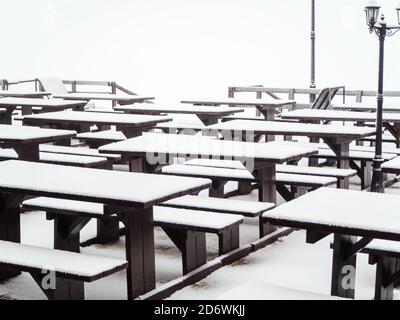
[31,272,85,300]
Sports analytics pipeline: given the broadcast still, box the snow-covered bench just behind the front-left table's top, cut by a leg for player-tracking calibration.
[0,149,109,169]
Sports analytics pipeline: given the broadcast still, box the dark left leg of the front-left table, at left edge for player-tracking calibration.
[0,193,22,281]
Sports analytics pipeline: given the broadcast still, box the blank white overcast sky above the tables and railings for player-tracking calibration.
[0,0,400,101]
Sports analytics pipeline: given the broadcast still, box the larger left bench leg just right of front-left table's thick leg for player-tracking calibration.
[163,228,207,274]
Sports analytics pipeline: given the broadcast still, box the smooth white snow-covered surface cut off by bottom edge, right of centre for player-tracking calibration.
[218,281,344,300]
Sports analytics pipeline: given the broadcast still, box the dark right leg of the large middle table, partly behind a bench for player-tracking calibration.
[255,165,276,238]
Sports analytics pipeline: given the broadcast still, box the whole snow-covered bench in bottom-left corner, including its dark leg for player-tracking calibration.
[0,241,128,300]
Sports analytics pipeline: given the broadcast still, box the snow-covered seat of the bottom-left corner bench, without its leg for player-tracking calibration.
[0,240,128,282]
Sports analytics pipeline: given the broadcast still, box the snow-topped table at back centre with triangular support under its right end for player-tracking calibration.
[114,103,244,126]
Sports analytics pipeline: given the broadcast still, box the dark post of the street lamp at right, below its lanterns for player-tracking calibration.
[371,23,386,193]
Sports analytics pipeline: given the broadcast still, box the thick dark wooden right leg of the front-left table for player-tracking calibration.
[123,208,156,299]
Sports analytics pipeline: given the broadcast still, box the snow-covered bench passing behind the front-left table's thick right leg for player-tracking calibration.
[22,197,243,273]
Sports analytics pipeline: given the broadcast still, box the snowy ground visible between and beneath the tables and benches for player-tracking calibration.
[0,111,400,300]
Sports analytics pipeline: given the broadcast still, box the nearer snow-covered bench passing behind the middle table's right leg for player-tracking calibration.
[161,164,337,201]
